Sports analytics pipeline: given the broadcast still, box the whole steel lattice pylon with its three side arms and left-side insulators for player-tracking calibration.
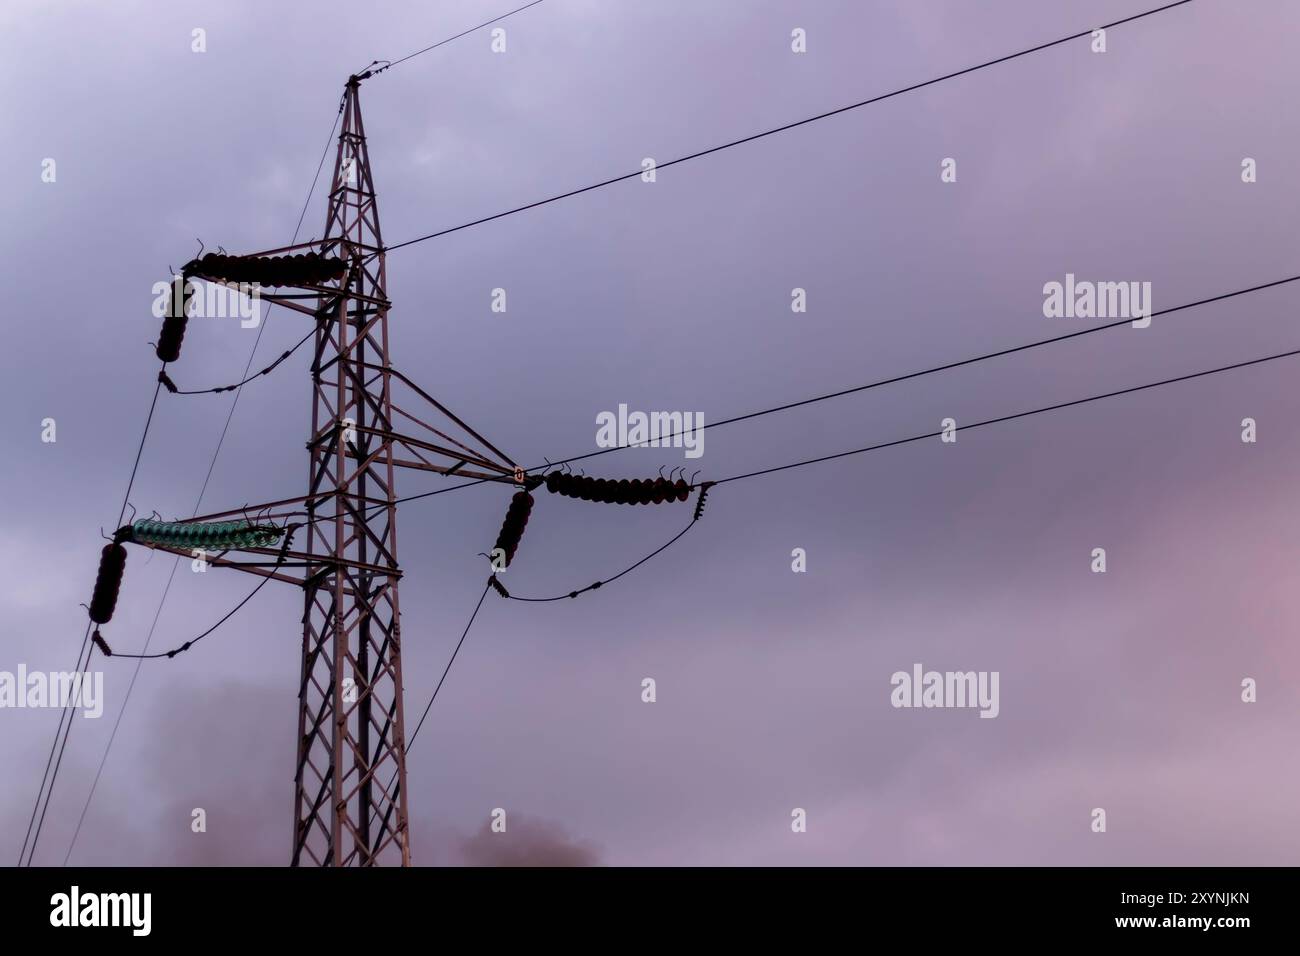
[100,72,523,866]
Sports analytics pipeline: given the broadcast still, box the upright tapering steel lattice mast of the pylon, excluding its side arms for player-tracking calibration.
[293,77,411,866]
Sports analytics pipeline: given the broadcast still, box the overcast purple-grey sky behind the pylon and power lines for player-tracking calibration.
[0,0,1300,865]
